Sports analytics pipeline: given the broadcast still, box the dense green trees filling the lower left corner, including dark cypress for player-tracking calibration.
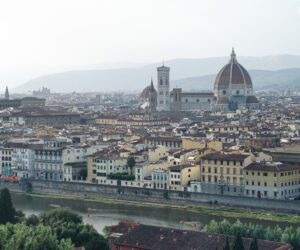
[0,189,109,250]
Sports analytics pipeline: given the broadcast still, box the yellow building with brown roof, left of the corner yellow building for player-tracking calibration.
[200,153,252,195]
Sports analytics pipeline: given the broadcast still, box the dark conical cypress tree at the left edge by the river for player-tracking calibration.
[0,188,17,224]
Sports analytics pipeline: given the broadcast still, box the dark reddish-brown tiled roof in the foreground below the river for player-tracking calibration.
[110,224,290,250]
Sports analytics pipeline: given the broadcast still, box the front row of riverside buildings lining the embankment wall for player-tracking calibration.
[0,132,300,199]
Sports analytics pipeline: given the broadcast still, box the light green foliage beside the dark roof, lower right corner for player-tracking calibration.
[203,220,300,249]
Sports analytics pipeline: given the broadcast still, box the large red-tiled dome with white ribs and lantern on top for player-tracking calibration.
[215,49,252,90]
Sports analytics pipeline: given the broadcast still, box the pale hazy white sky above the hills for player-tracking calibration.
[0,0,300,88]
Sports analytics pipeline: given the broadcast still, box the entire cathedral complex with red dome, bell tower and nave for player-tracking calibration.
[141,49,258,113]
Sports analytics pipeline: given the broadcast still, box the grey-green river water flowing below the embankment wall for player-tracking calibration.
[12,193,296,233]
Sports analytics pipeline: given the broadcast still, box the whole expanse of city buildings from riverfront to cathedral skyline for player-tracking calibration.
[0,50,300,203]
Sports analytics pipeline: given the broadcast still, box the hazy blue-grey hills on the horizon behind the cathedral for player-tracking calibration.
[14,55,300,92]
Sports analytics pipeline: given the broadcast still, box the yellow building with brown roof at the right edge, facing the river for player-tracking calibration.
[244,162,300,199]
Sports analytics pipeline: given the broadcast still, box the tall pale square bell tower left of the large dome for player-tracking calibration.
[157,65,170,111]
